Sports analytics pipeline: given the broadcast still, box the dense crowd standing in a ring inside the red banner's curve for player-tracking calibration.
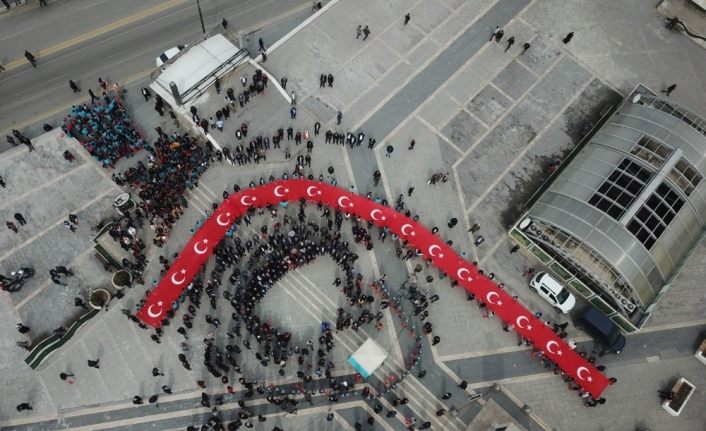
[114,181,446,429]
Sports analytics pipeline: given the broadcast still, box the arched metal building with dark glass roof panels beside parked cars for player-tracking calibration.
[511,86,706,331]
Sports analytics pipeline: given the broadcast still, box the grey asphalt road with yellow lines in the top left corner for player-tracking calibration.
[0,0,310,151]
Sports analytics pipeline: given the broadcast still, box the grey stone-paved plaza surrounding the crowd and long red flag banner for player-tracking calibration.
[0,0,706,431]
